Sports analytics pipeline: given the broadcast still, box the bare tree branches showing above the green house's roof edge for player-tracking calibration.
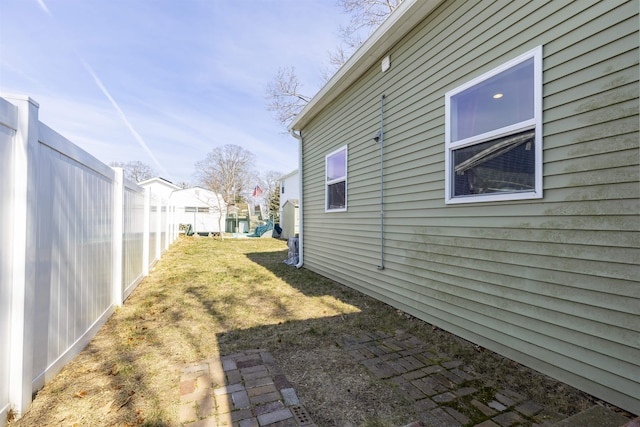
[265,0,402,126]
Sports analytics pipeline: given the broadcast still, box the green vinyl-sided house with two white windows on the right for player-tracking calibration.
[290,0,640,414]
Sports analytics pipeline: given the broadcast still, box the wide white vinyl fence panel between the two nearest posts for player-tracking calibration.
[33,124,114,388]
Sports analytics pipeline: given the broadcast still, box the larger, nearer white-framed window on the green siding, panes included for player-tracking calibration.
[445,47,542,203]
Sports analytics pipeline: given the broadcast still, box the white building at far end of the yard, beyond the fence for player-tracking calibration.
[169,187,227,233]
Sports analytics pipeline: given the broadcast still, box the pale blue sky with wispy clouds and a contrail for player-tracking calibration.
[0,0,348,183]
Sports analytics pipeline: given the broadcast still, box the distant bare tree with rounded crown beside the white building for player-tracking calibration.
[195,144,255,236]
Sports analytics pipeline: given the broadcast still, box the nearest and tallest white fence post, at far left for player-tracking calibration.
[7,97,39,416]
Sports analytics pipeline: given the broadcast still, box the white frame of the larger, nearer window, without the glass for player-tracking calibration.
[445,46,543,204]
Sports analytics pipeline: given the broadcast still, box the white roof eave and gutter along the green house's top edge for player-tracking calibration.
[288,0,444,131]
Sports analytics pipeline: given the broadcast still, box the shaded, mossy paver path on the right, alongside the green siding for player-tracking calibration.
[339,331,562,427]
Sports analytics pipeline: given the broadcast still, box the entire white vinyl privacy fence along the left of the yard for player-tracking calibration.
[0,96,177,426]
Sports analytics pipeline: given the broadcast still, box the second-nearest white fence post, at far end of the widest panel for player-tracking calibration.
[112,168,124,306]
